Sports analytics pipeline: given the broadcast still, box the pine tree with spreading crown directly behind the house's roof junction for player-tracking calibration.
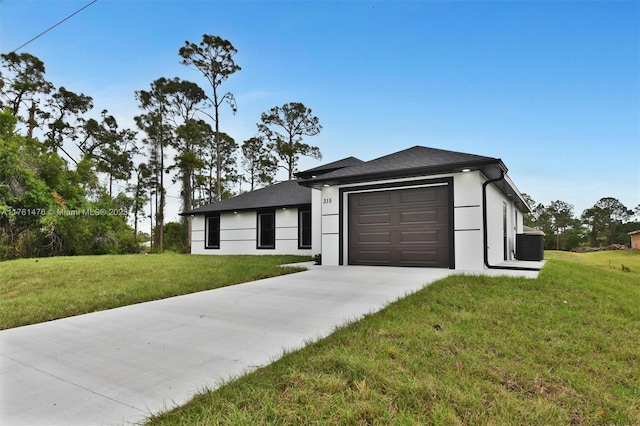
[258,102,322,180]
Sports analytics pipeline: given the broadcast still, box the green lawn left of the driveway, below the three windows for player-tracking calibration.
[0,253,310,329]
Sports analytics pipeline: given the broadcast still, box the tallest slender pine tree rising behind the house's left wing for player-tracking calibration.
[178,34,241,199]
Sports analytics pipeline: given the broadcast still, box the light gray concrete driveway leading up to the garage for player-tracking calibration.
[0,266,540,426]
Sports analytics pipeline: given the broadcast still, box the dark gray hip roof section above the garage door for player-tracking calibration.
[301,146,506,187]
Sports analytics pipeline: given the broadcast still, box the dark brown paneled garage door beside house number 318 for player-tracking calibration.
[348,186,449,268]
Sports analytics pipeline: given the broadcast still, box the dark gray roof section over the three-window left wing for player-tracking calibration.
[180,180,311,215]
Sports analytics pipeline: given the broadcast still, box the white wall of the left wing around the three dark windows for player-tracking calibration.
[191,208,319,256]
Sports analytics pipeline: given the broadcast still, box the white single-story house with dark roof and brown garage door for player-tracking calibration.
[182,146,529,270]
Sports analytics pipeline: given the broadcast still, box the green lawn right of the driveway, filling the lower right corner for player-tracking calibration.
[148,252,640,425]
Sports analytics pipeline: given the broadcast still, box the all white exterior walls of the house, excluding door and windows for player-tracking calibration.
[191,171,524,270]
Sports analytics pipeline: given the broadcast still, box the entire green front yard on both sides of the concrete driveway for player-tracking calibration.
[0,251,640,425]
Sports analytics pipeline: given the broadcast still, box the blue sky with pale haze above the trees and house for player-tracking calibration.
[0,0,640,223]
